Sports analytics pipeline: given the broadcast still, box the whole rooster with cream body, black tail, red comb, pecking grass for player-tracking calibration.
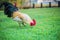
[0,2,36,26]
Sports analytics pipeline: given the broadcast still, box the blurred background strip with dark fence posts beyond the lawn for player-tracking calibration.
[0,0,60,8]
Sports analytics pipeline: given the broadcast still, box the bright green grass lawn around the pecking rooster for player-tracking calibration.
[0,8,60,40]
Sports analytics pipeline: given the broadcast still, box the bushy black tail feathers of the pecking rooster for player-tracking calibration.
[0,2,18,17]
